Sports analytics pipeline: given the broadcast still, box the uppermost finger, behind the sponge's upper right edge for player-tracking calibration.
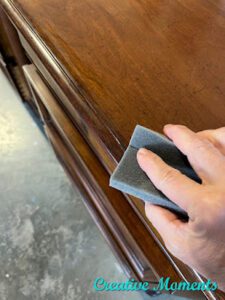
[164,125,225,183]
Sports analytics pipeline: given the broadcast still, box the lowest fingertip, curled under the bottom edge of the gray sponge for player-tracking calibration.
[145,203,186,245]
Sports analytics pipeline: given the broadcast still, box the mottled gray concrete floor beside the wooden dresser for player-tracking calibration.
[0,71,187,300]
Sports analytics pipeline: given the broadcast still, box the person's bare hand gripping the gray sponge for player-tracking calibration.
[137,125,225,291]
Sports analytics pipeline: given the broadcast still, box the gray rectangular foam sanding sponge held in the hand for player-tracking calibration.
[110,125,200,217]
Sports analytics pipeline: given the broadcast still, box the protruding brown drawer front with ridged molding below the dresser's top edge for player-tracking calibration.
[24,65,166,283]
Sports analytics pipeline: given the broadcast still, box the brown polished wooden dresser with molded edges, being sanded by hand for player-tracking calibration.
[0,0,225,299]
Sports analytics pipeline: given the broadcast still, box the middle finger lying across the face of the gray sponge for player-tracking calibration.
[137,149,201,212]
